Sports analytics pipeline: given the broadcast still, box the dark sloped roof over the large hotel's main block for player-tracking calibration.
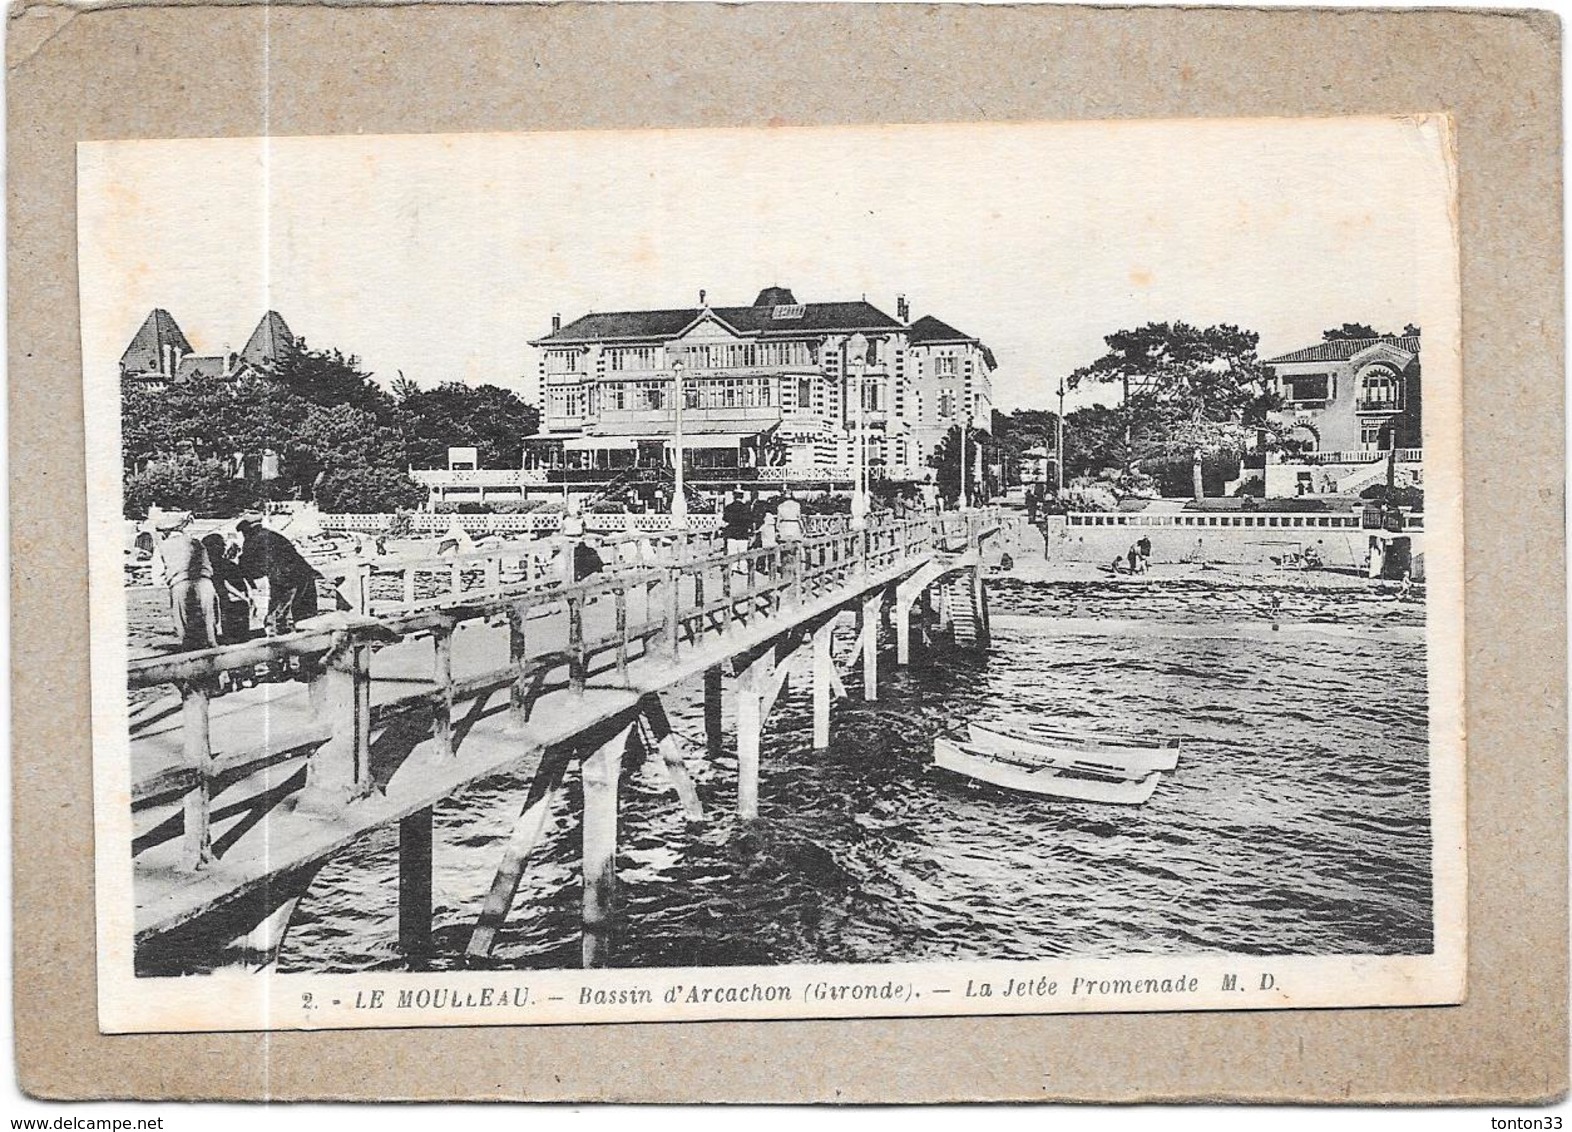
[530,288,901,346]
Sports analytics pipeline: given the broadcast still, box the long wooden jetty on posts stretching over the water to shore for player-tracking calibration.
[129,509,1001,967]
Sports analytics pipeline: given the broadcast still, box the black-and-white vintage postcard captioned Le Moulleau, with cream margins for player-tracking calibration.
[77,116,1467,1033]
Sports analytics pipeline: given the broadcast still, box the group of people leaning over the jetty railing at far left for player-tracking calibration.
[149,511,321,649]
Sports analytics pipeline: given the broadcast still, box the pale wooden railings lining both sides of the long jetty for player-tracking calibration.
[127,511,998,962]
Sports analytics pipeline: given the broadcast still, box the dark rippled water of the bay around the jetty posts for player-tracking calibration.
[281,583,1431,970]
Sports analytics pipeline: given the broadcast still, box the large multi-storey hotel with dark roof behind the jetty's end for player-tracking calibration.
[509,286,995,495]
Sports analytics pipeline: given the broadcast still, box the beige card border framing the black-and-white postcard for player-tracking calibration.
[9,5,1566,1101]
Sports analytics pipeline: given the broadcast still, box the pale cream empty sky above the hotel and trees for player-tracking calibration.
[79,118,1451,409]
